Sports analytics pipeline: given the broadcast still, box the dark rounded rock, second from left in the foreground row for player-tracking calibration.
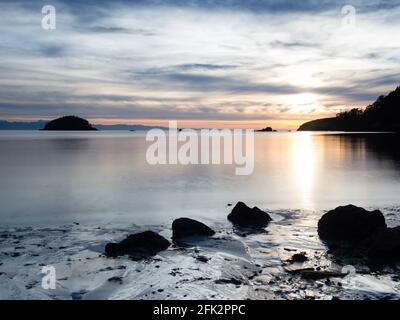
[172,218,215,239]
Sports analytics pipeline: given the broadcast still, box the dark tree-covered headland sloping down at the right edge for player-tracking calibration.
[298,87,400,132]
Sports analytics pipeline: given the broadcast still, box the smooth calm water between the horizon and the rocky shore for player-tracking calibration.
[0,131,400,226]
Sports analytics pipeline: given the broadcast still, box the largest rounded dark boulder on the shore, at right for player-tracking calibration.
[318,205,386,244]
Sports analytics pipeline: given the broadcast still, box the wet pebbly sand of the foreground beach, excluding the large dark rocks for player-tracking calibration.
[0,207,400,300]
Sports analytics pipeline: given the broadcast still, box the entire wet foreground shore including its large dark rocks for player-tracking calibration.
[0,203,400,299]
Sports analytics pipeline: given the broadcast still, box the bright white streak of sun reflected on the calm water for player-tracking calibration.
[291,133,315,208]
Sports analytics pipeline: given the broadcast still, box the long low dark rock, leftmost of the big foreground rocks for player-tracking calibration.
[105,231,170,260]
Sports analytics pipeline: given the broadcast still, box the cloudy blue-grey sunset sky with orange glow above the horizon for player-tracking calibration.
[0,0,400,129]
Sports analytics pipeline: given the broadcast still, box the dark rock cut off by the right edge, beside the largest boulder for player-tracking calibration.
[368,227,400,260]
